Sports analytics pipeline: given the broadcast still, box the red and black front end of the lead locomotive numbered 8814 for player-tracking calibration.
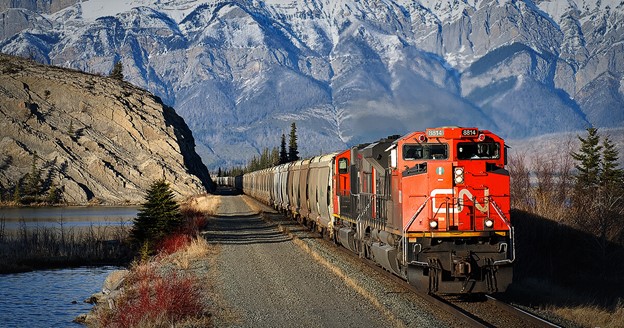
[391,127,514,293]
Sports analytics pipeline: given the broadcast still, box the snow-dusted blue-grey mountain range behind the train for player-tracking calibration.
[0,0,624,168]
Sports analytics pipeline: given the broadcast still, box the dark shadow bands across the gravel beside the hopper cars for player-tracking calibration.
[203,215,292,245]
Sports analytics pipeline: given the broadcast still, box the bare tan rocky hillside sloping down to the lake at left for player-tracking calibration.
[0,55,212,204]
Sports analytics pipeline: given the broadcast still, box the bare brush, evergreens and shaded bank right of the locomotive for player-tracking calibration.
[509,127,624,280]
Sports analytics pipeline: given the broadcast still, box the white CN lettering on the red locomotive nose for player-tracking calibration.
[431,188,490,213]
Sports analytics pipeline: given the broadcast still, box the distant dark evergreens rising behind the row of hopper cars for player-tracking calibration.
[217,122,299,177]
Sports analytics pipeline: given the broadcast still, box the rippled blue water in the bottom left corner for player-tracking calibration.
[0,266,116,327]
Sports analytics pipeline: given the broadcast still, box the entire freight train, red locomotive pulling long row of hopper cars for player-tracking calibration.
[217,127,515,294]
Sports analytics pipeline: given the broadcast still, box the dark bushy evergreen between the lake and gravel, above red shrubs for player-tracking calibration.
[131,179,183,253]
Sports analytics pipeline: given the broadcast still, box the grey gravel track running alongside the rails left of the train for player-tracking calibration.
[204,196,453,327]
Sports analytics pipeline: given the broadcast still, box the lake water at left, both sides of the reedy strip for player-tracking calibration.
[0,207,138,327]
